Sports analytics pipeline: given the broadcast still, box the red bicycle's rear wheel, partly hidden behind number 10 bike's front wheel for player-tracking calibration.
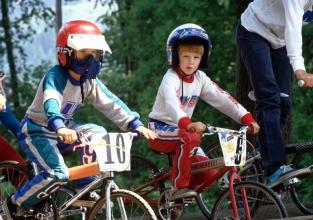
[115,154,166,205]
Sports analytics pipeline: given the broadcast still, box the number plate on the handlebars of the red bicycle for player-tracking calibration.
[218,129,246,166]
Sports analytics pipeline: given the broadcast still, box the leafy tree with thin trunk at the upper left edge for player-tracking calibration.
[0,0,54,107]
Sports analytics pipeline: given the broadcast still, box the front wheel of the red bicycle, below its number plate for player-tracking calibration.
[211,181,288,220]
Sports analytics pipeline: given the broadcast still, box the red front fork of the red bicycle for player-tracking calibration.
[228,167,251,220]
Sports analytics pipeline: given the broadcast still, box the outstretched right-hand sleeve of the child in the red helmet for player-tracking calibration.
[88,79,143,131]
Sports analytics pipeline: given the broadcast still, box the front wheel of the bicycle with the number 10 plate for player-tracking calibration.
[87,189,157,220]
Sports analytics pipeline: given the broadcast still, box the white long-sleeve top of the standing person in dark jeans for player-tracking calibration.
[241,0,313,71]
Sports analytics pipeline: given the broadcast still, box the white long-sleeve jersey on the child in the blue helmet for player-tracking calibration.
[149,69,248,126]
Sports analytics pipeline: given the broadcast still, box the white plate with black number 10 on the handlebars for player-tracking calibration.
[89,133,133,172]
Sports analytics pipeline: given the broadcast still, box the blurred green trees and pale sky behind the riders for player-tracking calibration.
[0,0,313,175]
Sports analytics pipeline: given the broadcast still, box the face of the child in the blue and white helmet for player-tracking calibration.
[178,47,202,75]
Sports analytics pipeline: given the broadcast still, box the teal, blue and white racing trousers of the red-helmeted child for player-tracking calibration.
[12,116,106,209]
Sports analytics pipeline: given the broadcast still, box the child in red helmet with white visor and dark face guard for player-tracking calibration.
[4,20,155,219]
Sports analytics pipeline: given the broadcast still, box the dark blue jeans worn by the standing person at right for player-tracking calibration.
[237,24,292,176]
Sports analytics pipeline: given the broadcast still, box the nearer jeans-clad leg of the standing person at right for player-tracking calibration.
[237,25,286,176]
